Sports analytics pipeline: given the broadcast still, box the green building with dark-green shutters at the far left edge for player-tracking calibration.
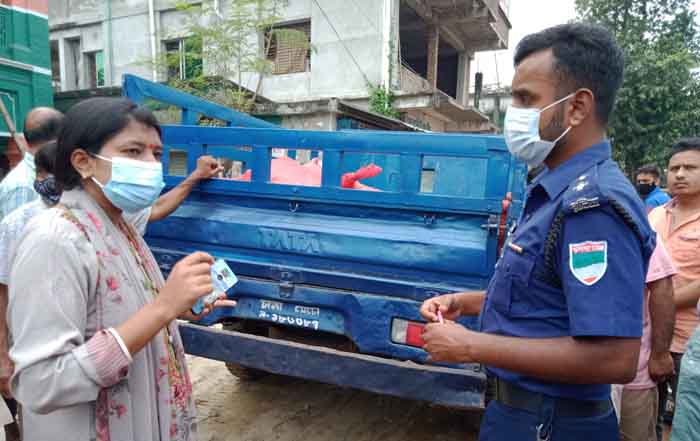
[0,0,53,163]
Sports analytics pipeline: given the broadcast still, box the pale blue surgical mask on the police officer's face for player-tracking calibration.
[503,93,575,168]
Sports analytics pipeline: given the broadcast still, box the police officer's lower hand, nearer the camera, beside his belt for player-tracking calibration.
[423,322,474,363]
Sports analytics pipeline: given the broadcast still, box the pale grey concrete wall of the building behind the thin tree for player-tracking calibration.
[49,0,398,102]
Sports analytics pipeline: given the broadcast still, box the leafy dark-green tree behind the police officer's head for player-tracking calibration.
[576,0,700,177]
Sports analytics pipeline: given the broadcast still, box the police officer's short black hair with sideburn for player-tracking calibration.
[515,23,625,125]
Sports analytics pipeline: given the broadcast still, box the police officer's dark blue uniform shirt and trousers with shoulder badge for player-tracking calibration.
[479,141,656,441]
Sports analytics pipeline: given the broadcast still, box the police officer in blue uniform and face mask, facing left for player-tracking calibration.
[421,24,655,441]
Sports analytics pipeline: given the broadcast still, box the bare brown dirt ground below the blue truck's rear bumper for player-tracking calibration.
[189,357,481,441]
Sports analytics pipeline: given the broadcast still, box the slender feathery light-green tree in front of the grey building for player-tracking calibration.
[164,0,311,112]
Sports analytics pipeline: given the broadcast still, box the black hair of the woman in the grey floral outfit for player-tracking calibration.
[54,98,161,190]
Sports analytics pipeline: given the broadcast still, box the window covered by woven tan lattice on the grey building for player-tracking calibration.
[264,20,311,75]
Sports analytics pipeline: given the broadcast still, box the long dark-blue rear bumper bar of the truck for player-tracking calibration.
[180,323,486,409]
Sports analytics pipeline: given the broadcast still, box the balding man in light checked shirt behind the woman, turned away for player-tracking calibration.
[0,107,63,220]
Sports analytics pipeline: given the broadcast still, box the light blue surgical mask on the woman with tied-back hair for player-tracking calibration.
[92,155,165,213]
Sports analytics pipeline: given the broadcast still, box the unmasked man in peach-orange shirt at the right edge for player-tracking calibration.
[649,137,700,439]
